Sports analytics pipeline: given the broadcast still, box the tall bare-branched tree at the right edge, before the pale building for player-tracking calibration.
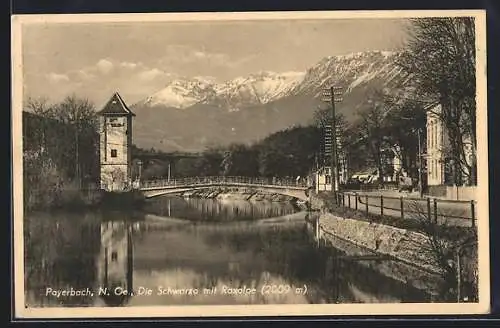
[398,17,477,184]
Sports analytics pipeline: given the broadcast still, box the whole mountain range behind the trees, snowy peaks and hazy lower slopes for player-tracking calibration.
[131,51,406,151]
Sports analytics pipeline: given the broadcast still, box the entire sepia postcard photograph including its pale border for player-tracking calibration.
[12,10,490,318]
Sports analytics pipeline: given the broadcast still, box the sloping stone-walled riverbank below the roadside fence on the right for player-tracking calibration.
[311,195,478,301]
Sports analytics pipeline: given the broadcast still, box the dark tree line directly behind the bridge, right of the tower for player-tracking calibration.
[142,126,321,180]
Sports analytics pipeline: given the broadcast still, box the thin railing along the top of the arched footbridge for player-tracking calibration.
[141,176,308,188]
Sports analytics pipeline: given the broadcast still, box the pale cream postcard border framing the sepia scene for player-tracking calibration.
[11,10,490,319]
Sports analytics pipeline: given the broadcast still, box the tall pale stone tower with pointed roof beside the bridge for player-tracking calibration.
[98,92,135,192]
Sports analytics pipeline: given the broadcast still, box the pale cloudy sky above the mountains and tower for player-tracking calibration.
[22,18,407,106]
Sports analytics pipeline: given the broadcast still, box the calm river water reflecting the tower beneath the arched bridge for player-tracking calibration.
[24,197,428,307]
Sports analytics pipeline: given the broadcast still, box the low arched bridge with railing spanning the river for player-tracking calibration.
[139,176,311,201]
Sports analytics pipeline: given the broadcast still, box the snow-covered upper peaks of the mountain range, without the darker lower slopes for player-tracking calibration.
[138,51,400,111]
